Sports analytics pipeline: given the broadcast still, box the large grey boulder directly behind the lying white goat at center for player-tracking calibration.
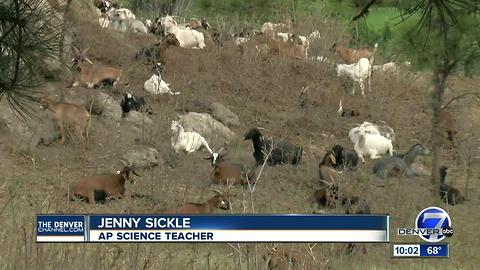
[179,112,235,146]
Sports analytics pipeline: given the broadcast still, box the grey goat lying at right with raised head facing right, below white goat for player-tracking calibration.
[373,143,430,178]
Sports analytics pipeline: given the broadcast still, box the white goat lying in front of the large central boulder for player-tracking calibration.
[170,121,213,154]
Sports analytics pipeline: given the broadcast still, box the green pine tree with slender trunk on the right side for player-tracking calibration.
[352,0,480,201]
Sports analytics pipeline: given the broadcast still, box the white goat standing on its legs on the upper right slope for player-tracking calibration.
[336,58,372,96]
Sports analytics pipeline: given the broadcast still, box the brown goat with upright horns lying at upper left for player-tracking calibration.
[71,47,122,88]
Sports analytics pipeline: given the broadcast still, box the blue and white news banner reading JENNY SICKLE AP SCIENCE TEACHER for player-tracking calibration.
[36,215,390,243]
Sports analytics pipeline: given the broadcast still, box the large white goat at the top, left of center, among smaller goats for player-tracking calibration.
[160,15,206,49]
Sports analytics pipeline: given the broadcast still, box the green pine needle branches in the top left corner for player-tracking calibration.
[0,0,62,116]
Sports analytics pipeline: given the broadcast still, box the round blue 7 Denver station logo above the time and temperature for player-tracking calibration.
[397,206,453,243]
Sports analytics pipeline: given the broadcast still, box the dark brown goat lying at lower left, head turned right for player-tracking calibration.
[70,166,139,204]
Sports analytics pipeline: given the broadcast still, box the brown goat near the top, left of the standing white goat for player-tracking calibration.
[267,33,307,59]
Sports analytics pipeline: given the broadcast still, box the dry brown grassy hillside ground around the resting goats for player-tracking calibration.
[0,2,480,269]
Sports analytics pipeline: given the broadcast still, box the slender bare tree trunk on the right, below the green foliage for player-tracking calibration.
[431,69,449,204]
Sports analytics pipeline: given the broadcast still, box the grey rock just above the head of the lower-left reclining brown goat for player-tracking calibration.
[122,146,162,169]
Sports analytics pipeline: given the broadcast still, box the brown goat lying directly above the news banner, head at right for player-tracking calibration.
[162,190,230,214]
